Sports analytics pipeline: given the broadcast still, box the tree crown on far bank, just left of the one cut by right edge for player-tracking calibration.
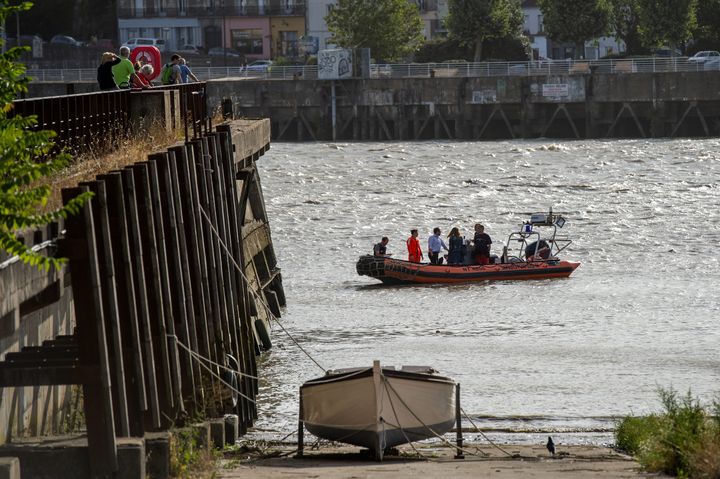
[637,0,704,52]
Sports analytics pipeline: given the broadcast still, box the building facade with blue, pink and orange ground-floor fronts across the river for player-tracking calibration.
[118,0,306,61]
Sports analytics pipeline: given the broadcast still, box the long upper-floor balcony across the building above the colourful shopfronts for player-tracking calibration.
[118,1,306,18]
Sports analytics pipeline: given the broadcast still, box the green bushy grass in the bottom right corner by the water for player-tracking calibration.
[615,389,720,479]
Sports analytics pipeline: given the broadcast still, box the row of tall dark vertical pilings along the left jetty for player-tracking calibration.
[38,126,284,475]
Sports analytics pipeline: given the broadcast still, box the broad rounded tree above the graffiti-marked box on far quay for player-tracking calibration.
[325,0,424,62]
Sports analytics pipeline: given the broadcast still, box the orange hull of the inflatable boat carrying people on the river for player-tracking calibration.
[356,255,580,284]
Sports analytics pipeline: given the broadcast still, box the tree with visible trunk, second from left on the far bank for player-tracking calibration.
[445,0,523,62]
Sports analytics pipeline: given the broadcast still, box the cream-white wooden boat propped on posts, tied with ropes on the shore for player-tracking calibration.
[298,361,462,461]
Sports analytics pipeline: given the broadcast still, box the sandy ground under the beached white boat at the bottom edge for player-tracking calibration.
[218,443,665,479]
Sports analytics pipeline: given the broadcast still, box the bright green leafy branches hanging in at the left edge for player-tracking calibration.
[0,3,89,269]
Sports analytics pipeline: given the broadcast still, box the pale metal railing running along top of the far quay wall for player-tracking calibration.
[27,57,720,82]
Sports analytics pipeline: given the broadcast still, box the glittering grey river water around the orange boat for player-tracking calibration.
[250,139,720,443]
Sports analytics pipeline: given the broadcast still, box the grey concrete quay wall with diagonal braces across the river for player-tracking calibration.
[208,72,720,141]
